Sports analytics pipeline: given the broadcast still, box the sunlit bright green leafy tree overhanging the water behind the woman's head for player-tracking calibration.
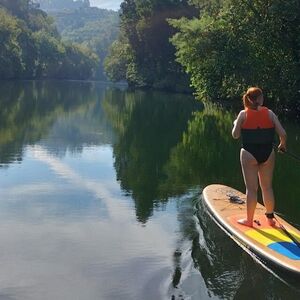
[171,0,300,111]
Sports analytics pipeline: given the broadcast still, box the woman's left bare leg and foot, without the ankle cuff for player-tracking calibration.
[238,149,258,226]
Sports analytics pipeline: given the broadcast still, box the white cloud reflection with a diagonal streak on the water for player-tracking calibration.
[0,145,176,300]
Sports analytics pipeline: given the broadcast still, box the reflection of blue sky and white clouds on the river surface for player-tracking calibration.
[0,145,180,299]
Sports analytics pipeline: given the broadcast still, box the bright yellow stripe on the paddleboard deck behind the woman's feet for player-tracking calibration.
[245,228,300,246]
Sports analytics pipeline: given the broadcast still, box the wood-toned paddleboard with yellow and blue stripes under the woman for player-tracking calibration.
[203,184,300,276]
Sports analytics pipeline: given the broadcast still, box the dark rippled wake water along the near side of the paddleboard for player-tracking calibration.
[169,189,300,299]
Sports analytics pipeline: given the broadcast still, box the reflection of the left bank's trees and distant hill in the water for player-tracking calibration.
[0,81,112,164]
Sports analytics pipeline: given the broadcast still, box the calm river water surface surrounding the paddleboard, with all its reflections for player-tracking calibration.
[0,82,300,300]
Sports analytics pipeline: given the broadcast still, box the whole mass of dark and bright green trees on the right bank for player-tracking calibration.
[105,0,300,111]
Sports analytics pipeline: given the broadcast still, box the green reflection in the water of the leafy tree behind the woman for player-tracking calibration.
[161,101,300,226]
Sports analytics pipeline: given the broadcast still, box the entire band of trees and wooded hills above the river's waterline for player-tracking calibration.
[0,0,300,117]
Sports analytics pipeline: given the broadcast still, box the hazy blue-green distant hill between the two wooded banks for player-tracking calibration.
[35,0,119,79]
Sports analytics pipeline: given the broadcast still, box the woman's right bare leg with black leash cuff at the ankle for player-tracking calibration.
[258,151,275,226]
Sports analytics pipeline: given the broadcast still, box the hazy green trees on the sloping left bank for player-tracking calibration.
[0,0,98,79]
